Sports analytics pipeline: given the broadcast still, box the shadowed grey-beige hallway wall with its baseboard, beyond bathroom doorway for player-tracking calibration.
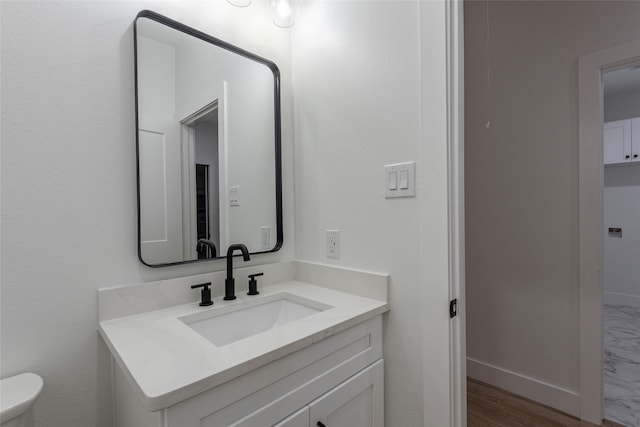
[465,1,640,413]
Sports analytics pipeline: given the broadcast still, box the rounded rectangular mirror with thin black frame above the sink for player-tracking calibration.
[134,11,282,266]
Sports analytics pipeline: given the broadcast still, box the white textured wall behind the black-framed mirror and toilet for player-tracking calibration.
[0,1,294,427]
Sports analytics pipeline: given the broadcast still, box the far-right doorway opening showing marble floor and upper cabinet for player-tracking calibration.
[602,63,640,427]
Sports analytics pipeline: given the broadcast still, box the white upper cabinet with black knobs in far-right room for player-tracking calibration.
[604,117,640,165]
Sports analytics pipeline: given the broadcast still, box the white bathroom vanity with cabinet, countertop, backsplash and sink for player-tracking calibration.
[99,261,388,427]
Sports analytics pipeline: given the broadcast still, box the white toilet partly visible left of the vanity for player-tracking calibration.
[0,372,43,427]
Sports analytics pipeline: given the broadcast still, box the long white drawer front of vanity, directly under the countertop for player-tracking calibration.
[164,316,382,427]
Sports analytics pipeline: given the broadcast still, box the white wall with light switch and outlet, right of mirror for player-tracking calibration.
[292,1,449,427]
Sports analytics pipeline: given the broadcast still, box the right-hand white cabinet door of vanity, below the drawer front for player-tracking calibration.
[309,360,384,427]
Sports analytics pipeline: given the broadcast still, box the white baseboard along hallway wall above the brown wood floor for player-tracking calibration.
[467,357,580,418]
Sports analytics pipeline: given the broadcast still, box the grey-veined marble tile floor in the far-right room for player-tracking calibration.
[604,305,640,427]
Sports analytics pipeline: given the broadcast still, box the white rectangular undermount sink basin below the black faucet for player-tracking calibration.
[180,294,330,347]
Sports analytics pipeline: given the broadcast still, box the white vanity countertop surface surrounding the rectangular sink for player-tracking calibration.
[99,280,388,411]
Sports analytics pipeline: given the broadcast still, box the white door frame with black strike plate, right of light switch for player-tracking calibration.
[417,0,466,427]
